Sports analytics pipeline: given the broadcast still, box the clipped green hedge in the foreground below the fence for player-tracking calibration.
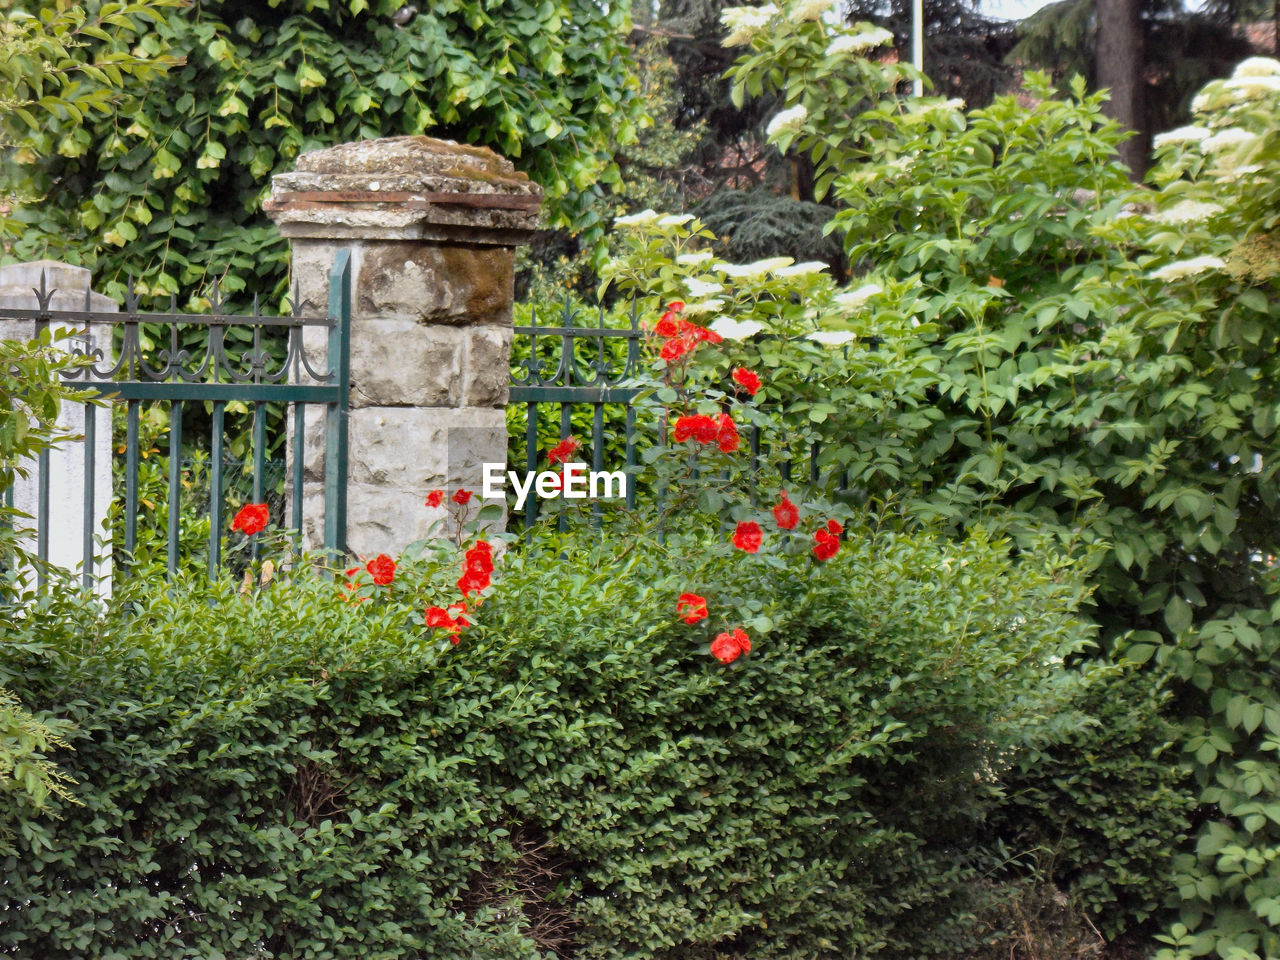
[0,532,1182,960]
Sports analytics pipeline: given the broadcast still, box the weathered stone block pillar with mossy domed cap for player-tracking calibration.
[265,137,541,556]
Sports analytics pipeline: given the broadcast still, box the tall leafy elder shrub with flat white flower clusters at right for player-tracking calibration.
[706,5,1280,957]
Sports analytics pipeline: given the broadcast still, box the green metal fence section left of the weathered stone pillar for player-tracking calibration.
[0,250,352,588]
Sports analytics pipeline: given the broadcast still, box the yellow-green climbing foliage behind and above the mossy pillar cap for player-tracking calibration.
[0,0,636,305]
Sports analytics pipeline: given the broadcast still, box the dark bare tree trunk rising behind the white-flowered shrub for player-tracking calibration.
[1094,0,1148,180]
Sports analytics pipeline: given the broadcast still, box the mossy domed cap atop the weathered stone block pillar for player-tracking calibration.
[262,137,543,247]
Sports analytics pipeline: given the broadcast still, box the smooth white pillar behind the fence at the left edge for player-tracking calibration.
[0,260,119,594]
